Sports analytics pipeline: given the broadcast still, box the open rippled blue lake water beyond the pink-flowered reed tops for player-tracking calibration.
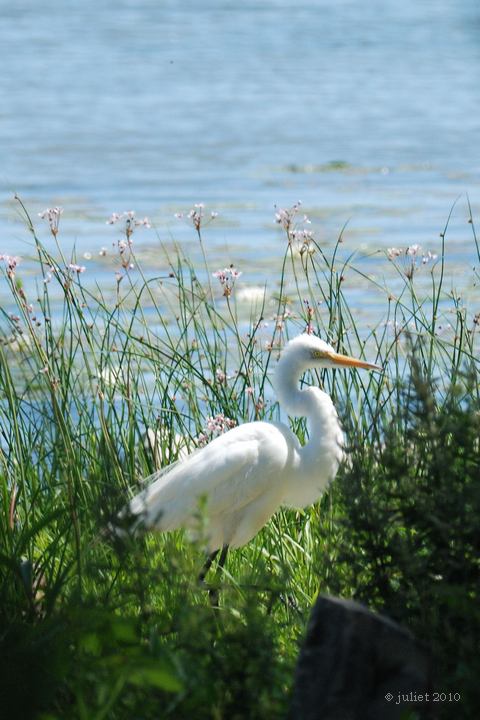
[0,0,480,320]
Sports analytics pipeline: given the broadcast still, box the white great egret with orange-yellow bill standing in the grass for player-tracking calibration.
[127,334,381,552]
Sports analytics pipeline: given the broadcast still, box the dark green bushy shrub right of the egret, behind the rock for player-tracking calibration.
[322,361,480,718]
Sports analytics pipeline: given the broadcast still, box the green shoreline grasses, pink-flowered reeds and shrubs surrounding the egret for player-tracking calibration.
[0,200,480,720]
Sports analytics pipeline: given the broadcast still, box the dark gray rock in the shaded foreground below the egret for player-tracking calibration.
[290,596,433,720]
